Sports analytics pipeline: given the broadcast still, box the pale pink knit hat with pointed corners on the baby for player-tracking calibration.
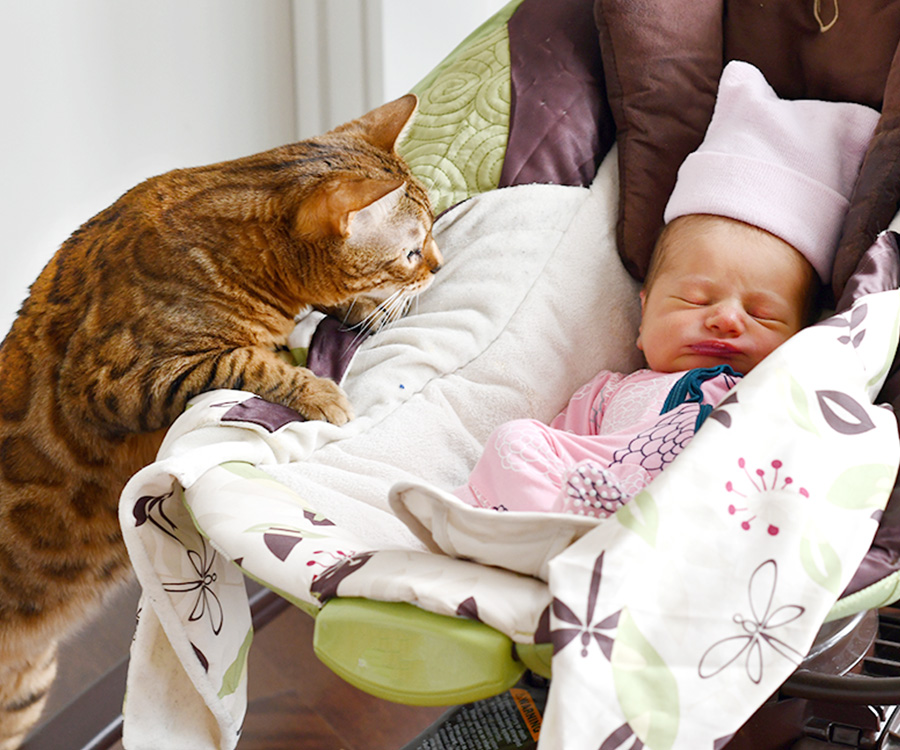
[664,60,880,283]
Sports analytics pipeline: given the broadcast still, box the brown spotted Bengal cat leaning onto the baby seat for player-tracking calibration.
[0,95,441,750]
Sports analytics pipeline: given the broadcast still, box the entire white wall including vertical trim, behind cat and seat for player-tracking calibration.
[0,0,506,336]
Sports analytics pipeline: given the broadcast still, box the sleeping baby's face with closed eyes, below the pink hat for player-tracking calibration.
[638,215,814,374]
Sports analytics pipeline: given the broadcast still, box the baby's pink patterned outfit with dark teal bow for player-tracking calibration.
[454,366,740,518]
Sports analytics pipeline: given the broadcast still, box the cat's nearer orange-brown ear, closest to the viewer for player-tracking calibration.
[297,179,406,237]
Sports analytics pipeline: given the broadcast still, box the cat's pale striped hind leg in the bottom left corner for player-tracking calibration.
[0,643,56,750]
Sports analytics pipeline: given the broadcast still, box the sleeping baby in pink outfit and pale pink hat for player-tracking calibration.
[454,61,879,518]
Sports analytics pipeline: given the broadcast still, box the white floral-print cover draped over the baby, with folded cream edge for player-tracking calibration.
[392,292,900,750]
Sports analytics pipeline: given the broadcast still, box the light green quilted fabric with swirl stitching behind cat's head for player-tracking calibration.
[398,0,522,213]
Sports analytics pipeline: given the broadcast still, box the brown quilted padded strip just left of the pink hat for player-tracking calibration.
[594,0,722,279]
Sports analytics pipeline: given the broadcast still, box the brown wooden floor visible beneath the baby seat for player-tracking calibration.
[29,586,445,750]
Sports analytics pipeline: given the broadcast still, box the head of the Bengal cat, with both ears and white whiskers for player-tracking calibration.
[295,94,443,327]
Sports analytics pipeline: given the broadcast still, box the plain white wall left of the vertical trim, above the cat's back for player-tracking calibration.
[0,0,295,335]
